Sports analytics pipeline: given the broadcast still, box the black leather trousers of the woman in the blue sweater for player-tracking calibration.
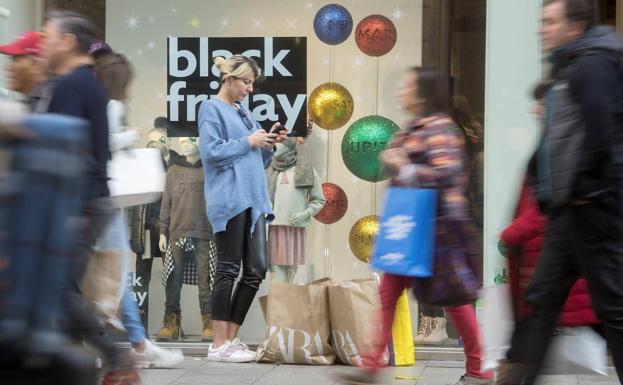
[212,209,268,325]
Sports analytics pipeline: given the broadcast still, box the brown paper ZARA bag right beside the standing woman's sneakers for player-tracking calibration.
[257,280,335,365]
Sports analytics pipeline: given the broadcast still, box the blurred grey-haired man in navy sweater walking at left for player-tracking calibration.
[41,11,138,378]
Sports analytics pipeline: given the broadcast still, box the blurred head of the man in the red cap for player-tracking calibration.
[0,32,47,110]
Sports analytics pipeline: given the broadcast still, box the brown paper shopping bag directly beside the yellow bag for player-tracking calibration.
[329,279,380,366]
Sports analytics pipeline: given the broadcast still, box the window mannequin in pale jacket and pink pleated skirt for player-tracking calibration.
[266,138,325,283]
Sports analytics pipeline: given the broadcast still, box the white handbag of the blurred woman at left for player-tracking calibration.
[108,148,166,207]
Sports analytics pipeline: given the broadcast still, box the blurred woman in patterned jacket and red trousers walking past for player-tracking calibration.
[343,67,494,385]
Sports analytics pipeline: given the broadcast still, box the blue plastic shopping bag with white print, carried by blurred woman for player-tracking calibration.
[372,187,437,277]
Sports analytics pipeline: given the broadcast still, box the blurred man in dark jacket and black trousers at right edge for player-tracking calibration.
[498,0,623,384]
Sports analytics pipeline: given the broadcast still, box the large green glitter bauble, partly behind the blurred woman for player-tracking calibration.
[342,115,400,182]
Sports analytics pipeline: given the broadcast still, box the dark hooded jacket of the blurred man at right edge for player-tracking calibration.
[535,26,623,214]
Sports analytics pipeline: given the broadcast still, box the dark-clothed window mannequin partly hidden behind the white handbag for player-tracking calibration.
[128,121,171,330]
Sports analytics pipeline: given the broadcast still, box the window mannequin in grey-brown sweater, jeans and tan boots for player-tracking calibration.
[158,138,216,341]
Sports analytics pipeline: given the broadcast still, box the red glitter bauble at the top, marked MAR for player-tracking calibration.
[355,15,398,56]
